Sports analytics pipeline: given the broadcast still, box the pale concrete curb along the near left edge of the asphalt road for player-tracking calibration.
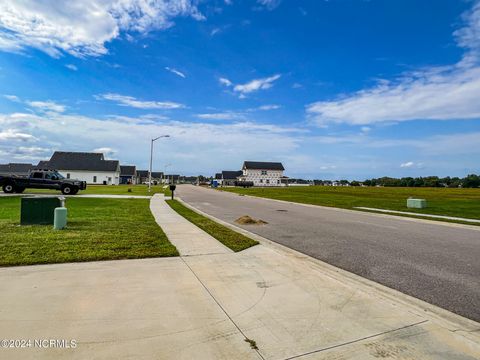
[177,196,480,342]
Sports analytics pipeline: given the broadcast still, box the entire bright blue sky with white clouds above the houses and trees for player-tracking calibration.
[0,0,480,179]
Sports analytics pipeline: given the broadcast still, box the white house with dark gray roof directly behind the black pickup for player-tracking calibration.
[37,151,120,185]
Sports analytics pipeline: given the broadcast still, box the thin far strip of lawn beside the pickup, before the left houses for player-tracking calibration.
[17,185,168,195]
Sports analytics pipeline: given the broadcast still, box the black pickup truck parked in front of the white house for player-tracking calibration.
[0,170,87,195]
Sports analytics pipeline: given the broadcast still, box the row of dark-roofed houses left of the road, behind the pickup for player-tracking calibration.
[0,151,180,185]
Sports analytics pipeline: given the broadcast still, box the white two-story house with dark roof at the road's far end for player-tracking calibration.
[239,161,285,186]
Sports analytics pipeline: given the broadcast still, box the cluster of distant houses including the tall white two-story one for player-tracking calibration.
[214,161,288,186]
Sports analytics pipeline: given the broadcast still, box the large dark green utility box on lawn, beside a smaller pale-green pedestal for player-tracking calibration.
[20,196,65,225]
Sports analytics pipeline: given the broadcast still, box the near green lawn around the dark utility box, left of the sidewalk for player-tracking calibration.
[0,197,178,266]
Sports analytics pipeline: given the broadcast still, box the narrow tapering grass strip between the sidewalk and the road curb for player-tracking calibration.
[167,200,258,252]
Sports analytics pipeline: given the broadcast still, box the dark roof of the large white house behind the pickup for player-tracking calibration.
[38,151,120,171]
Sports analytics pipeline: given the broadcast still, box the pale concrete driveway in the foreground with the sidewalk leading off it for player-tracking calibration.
[0,197,480,360]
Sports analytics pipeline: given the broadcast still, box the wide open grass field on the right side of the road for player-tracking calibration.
[221,186,480,219]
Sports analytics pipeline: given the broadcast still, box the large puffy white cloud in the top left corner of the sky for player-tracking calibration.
[0,0,204,57]
